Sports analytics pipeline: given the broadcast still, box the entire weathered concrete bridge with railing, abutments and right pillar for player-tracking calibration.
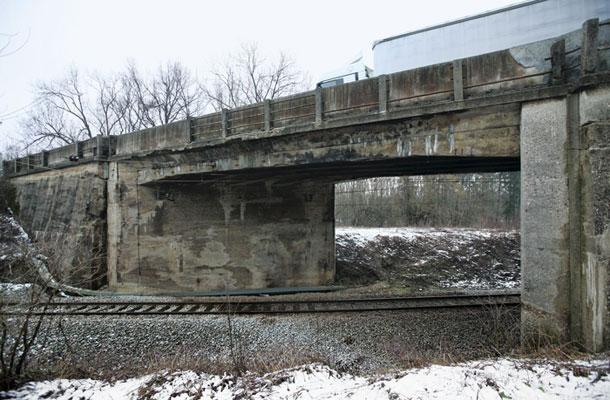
[3,20,610,350]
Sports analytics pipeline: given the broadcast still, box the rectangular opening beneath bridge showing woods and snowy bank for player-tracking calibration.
[335,171,521,295]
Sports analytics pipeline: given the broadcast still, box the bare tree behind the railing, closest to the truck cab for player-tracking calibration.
[203,43,309,111]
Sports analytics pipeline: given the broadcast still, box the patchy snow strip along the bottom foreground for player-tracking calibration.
[5,359,610,400]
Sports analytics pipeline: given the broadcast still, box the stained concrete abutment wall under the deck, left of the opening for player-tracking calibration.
[108,163,335,293]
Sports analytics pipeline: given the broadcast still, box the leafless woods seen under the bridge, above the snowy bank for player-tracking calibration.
[335,172,520,229]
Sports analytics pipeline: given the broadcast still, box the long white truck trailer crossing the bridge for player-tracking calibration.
[373,0,610,75]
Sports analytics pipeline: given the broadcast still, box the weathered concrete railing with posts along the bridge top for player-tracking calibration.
[3,20,610,176]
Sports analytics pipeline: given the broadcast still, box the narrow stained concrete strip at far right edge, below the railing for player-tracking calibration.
[575,87,610,350]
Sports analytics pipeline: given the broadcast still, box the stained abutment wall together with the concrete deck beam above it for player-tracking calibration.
[101,106,520,293]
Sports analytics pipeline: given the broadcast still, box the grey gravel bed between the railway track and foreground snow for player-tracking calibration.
[15,308,519,377]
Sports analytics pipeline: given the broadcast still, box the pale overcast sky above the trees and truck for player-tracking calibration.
[0,0,516,149]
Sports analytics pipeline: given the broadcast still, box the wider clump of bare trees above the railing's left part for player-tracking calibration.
[21,62,205,150]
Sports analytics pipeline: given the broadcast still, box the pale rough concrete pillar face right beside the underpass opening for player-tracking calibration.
[521,98,570,339]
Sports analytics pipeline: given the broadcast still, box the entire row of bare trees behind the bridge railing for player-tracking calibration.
[16,44,308,151]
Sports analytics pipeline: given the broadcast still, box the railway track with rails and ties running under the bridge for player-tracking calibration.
[0,292,521,316]
